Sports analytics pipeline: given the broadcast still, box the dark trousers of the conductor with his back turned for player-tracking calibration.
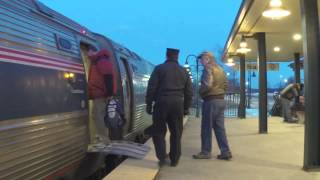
[152,96,183,162]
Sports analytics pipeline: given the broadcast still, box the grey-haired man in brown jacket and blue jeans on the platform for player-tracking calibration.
[193,52,232,160]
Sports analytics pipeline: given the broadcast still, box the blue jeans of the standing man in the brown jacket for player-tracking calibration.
[201,99,230,154]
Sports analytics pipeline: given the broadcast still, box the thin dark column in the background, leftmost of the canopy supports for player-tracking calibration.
[238,54,246,119]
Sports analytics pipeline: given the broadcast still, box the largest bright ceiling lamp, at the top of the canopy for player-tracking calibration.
[262,0,291,20]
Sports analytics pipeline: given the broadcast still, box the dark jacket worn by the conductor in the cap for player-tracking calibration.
[146,60,193,110]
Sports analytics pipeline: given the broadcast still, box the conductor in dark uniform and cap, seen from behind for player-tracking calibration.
[146,48,193,166]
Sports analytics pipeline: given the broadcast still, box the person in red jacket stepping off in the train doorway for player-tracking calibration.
[88,47,117,144]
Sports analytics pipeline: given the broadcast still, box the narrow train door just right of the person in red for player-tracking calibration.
[119,57,134,135]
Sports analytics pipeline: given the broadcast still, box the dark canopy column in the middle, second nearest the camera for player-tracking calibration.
[255,32,268,134]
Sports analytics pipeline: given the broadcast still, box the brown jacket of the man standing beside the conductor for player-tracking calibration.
[199,65,228,99]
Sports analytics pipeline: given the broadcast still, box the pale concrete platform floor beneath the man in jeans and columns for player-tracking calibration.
[156,118,320,180]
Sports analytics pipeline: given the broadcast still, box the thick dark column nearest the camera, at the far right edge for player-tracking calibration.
[300,0,320,170]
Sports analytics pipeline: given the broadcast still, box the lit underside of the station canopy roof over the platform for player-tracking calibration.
[224,0,310,62]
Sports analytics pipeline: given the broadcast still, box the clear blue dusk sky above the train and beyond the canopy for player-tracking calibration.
[41,0,300,88]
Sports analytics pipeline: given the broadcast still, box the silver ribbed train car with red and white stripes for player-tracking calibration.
[0,0,153,180]
